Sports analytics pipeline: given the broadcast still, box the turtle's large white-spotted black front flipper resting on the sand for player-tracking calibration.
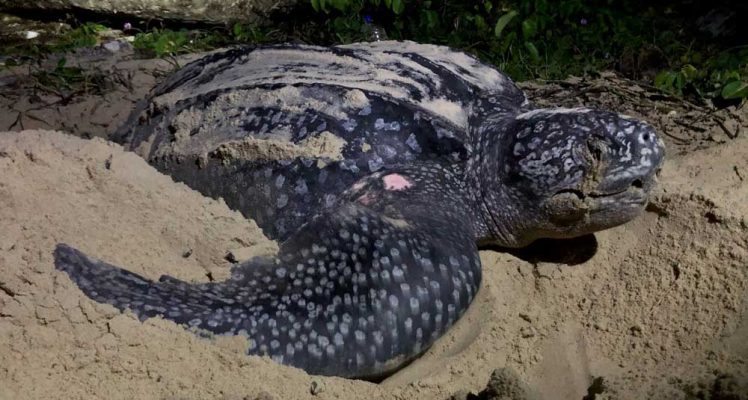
[55,165,480,378]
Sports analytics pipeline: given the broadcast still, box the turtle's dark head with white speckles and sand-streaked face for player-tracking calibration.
[489,108,665,246]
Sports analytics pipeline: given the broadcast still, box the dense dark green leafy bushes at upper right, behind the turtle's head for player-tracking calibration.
[302,0,748,99]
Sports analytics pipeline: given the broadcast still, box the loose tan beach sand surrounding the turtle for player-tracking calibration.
[0,44,748,399]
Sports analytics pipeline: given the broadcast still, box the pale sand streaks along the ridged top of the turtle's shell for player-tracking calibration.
[153,41,482,128]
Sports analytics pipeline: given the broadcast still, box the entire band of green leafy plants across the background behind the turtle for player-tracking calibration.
[3,0,748,102]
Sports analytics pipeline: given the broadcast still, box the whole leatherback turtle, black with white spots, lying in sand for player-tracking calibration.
[55,42,664,378]
